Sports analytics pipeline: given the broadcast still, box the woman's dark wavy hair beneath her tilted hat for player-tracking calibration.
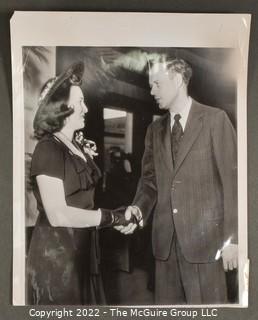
[34,78,75,139]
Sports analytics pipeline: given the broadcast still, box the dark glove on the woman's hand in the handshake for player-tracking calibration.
[99,207,137,228]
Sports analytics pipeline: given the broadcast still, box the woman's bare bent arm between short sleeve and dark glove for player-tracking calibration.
[36,175,101,228]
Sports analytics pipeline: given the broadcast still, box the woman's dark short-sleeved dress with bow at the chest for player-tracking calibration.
[27,135,105,305]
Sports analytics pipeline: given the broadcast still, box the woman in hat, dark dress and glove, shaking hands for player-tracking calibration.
[27,63,128,305]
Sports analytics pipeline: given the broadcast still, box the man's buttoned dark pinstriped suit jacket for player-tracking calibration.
[134,100,237,263]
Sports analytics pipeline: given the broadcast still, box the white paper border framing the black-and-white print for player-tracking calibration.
[11,11,251,307]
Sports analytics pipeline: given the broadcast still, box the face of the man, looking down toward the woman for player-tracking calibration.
[149,63,182,110]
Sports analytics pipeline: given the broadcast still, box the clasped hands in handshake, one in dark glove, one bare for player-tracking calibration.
[100,206,142,234]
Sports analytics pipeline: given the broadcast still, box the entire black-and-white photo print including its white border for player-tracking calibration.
[11,12,250,307]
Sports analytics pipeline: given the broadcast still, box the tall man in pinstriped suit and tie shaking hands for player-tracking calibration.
[118,59,238,304]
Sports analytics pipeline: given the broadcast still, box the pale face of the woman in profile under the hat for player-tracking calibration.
[68,86,88,130]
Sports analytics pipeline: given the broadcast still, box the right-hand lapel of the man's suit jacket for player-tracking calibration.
[173,100,203,177]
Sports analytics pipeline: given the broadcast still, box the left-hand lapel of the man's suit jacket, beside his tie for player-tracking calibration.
[157,112,173,172]
